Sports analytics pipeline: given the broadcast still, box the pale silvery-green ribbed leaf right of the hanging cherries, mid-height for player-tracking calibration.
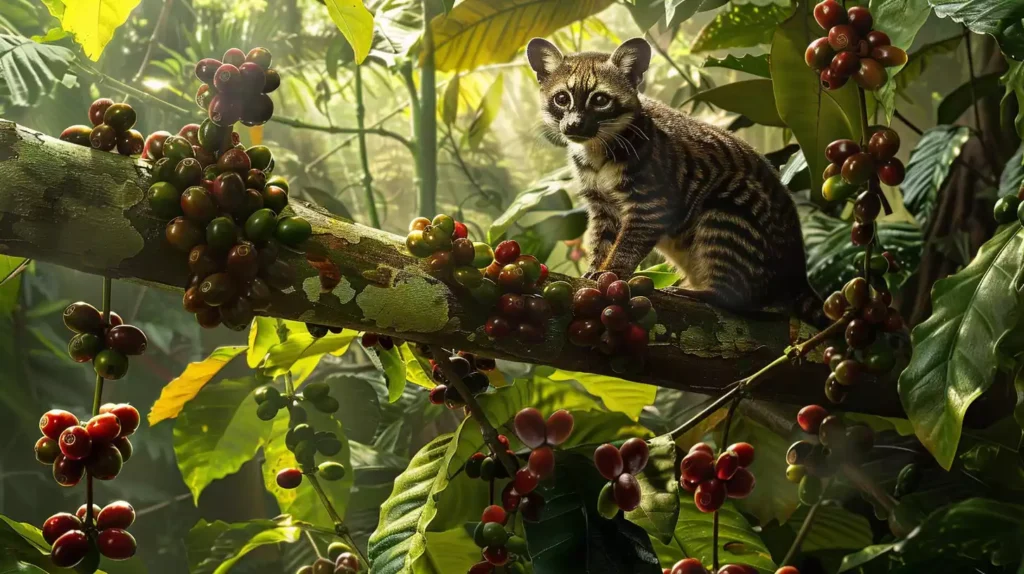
[900,126,971,227]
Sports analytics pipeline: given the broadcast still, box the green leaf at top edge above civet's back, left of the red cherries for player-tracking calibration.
[690,4,790,53]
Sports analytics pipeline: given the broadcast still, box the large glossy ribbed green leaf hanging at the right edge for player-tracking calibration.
[899,223,1024,469]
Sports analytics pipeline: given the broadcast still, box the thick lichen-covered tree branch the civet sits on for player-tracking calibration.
[0,120,902,416]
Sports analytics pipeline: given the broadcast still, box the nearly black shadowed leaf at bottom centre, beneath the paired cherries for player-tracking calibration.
[524,450,660,574]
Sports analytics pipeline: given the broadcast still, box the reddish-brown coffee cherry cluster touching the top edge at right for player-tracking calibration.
[804,0,906,91]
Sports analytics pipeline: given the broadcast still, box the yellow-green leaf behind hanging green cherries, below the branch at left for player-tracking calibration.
[263,405,355,529]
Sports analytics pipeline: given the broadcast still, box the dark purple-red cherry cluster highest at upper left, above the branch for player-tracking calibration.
[196,48,281,126]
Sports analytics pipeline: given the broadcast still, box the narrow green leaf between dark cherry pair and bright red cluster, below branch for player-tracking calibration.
[626,435,679,543]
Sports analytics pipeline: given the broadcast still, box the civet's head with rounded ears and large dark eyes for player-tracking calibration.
[526,38,650,143]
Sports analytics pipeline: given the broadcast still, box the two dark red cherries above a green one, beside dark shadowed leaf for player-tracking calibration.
[594,438,650,520]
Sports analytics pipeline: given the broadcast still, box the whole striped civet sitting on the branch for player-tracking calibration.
[527,39,809,309]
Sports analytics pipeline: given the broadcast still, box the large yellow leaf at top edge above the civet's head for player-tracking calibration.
[430,0,611,72]
